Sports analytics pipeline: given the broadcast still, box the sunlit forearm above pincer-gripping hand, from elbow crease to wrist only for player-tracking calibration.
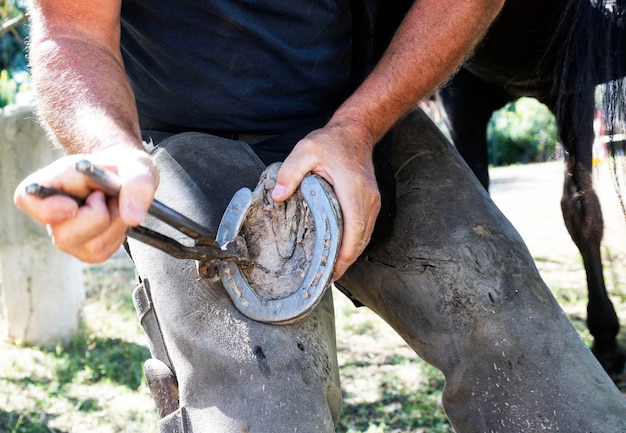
[29,3,141,153]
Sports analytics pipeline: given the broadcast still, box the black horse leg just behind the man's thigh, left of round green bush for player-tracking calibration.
[439,68,509,189]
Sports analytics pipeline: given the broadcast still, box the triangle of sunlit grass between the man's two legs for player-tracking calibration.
[335,292,452,433]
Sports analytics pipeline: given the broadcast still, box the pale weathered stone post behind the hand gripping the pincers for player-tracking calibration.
[0,106,85,347]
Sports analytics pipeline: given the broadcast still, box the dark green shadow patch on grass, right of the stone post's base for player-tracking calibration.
[48,333,150,390]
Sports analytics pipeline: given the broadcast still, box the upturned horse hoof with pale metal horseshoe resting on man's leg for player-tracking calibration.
[217,164,342,324]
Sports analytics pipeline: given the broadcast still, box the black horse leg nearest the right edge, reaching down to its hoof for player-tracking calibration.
[557,88,626,376]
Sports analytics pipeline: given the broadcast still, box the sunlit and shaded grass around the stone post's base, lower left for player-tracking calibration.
[0,253,156,433]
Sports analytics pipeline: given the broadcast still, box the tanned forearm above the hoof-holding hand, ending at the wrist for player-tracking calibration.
[331,0,504,143]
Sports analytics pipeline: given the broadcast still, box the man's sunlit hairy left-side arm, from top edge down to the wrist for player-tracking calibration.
[29,0,141,153]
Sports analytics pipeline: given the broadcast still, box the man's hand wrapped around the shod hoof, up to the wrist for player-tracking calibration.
[272,124,380,281]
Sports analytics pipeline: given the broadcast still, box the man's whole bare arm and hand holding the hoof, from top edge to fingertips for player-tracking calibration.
[273,0,504,280]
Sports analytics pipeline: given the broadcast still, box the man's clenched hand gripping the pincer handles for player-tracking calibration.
[14,146,159,263]
